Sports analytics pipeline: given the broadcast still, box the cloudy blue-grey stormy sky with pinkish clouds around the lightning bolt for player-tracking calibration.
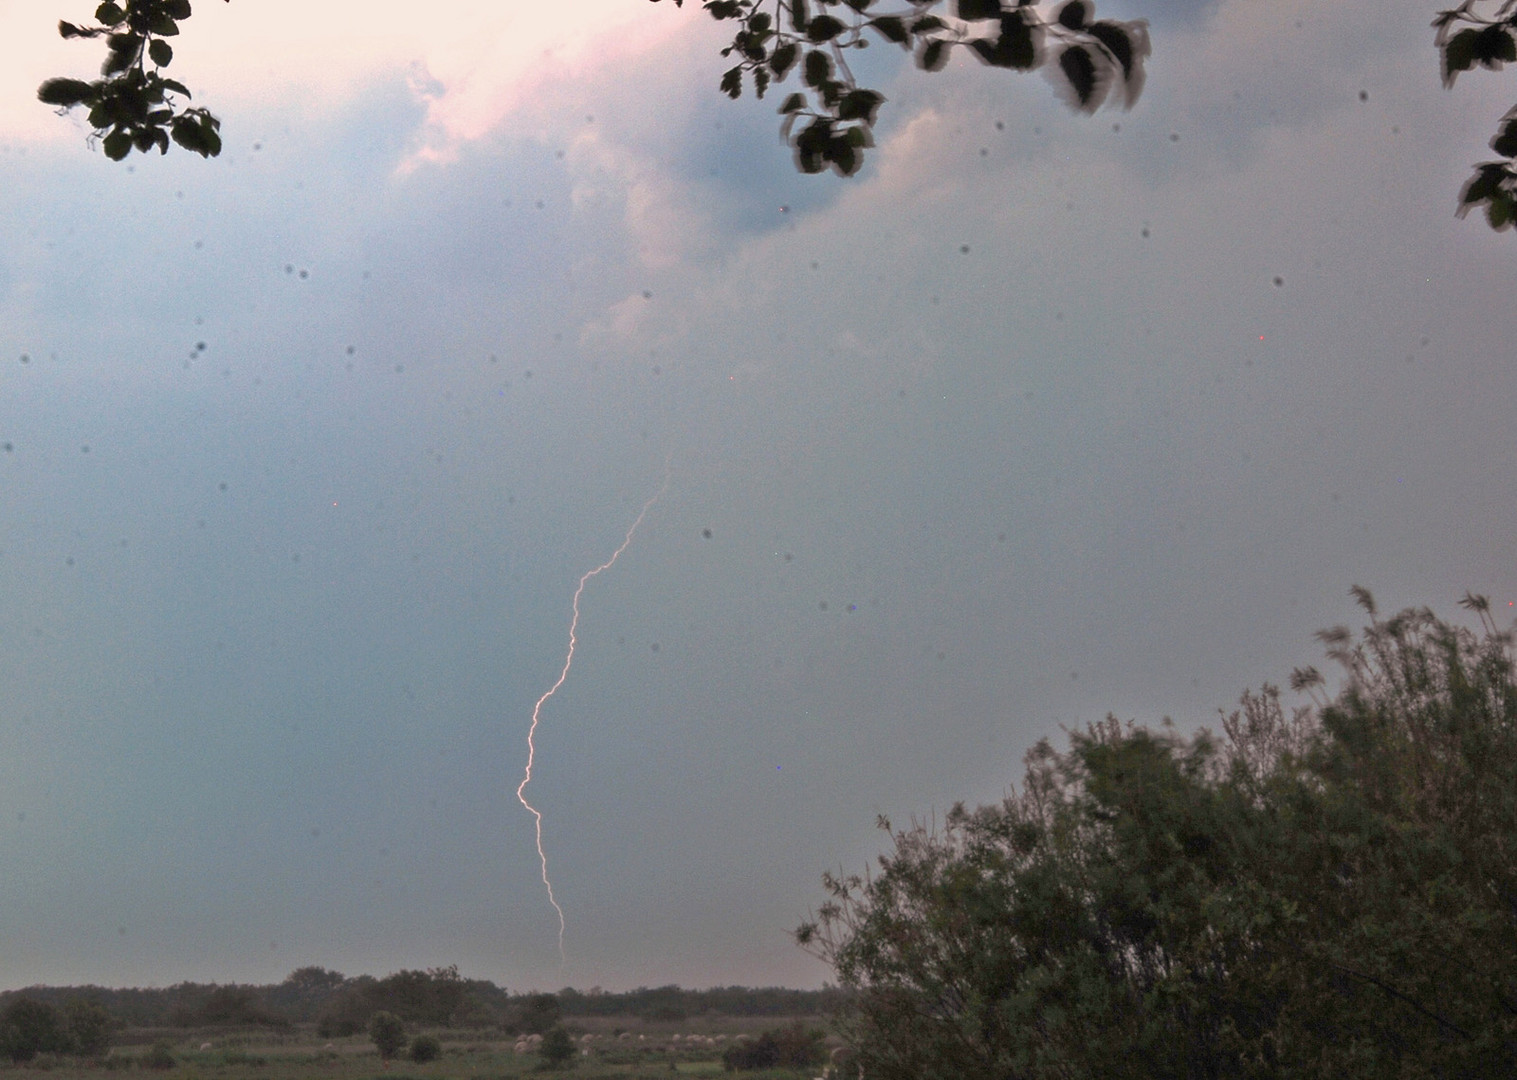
[0,0,1517,991]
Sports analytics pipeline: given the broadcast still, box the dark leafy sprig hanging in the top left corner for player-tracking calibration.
[36,0,221,161]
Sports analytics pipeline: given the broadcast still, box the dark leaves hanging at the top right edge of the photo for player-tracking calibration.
[1432,0,1517,232]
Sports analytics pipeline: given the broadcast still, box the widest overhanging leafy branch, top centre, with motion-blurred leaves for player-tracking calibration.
[654,0,1148,176]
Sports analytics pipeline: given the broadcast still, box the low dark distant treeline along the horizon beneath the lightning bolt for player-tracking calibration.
[0,966,840,1038]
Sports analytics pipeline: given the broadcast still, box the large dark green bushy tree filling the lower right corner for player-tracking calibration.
[798,590,1517,1080]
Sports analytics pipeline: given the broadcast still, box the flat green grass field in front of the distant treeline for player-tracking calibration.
[0,1016,822,1080]
